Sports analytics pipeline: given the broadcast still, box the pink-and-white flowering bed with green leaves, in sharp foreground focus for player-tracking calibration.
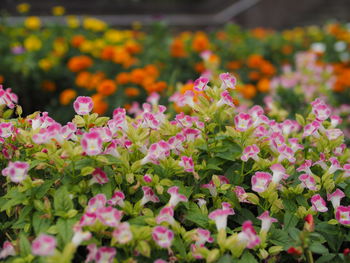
[0,69,350,262]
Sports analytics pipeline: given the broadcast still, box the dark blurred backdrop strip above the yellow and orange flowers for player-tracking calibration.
[0,0,350,29]
